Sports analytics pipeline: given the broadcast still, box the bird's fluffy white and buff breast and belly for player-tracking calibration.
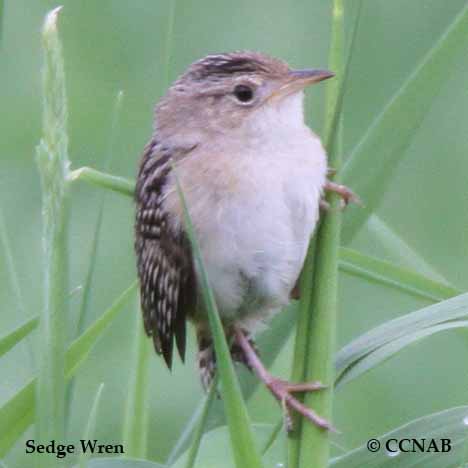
[166,90,326,326]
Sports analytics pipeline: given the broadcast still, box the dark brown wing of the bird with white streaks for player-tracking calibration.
[135,140,196,369]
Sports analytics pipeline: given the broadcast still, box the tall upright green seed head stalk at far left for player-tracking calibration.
[36,8,69,460]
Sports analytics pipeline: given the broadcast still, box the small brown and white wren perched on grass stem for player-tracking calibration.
[135,51,354,429]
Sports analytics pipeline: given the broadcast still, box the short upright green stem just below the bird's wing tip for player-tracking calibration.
[123,299,152,458]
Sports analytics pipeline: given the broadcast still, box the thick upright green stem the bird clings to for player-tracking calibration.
[296,0,359,468]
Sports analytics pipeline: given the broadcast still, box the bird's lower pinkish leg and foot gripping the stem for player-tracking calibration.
[235,328,334,430]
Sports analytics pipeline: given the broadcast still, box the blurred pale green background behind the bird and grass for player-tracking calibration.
[0,0,468,468]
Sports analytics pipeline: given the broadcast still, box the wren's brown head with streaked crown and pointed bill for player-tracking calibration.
[156,52,334,144]
